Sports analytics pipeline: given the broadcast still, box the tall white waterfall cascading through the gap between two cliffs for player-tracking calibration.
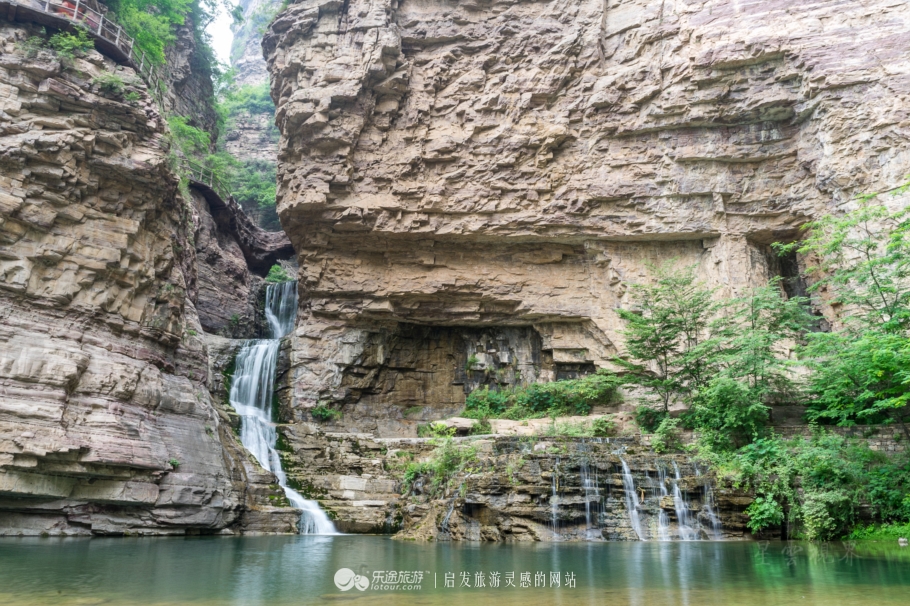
[230,282,337,534]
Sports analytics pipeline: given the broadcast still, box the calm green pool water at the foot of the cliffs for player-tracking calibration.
[0,536,910,606]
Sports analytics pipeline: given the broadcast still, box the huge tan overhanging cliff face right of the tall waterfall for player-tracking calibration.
[263,0,910,434]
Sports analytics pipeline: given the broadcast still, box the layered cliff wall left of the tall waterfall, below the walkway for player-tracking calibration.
[0,21,297,534]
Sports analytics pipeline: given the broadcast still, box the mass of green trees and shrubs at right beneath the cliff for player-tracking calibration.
[618,185,910,540]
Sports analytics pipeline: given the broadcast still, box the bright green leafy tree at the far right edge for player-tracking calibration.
[779,190,910,432]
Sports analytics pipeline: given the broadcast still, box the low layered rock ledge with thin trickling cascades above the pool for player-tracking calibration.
[279,423,752,542]
